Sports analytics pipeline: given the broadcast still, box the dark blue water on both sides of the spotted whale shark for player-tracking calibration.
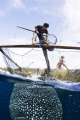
[0,76,80,120]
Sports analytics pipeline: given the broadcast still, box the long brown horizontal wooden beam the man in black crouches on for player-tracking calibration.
[0,44,80,50]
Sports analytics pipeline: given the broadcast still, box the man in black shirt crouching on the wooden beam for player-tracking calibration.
[32,23,49,44]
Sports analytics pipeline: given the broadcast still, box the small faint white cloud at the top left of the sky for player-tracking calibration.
[10,0,25,9]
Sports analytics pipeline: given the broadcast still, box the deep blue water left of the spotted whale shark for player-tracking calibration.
[0,81,14,120]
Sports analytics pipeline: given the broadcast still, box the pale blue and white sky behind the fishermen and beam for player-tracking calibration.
[0,0,80,68]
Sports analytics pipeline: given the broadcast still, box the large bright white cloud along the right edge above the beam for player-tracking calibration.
[62,0,80,45]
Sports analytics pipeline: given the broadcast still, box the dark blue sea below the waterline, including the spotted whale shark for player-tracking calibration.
[0,74,80,120]
